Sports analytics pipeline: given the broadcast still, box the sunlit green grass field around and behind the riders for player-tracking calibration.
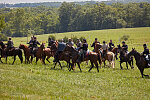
[0,27,150,100]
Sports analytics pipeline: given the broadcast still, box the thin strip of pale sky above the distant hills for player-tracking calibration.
[0,0,107,4]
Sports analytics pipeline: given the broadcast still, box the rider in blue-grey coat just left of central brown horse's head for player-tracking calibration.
[53,42,66,62]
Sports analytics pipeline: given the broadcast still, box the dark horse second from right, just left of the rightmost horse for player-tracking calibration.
[118,45,134,69]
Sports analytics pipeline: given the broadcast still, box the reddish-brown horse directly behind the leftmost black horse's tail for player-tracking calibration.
[19,44,33,63]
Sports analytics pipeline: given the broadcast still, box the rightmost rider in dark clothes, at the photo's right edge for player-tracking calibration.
[142,44,150,66]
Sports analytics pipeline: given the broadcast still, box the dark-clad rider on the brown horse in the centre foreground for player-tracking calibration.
[77,39,88,62]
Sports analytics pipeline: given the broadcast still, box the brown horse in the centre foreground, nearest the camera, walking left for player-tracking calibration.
[65,46,101,72]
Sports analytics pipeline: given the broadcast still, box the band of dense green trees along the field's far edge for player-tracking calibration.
[0,2,150,37]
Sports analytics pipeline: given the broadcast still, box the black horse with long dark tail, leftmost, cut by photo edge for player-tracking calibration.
[0,41,23,64]
